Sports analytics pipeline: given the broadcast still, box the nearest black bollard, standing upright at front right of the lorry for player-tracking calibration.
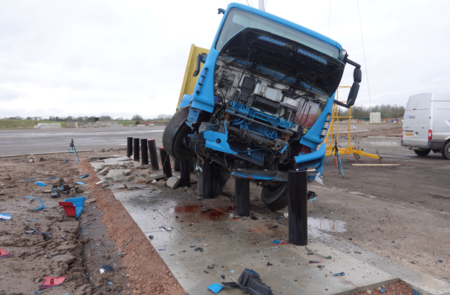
[288,170,308,246]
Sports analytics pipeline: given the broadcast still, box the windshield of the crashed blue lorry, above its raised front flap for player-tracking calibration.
[216,8,339,59]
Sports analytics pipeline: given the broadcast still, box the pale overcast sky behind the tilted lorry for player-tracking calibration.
[0,0,450,118]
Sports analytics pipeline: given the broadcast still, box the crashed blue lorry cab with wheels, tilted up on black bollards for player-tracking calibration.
[163,3,361,210]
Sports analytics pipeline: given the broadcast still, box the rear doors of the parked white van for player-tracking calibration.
[403,93,432,148]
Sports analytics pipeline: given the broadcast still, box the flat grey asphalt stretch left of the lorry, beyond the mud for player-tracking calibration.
[0,126,165,156]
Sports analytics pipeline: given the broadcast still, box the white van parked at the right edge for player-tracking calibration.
[402,93,450,160]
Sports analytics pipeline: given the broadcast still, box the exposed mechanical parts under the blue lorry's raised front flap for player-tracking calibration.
[193,57,326,169]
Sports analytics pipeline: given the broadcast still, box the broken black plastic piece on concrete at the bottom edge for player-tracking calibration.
[222,268,274,295]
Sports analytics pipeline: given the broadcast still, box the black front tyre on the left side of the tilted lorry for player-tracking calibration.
[163,107,192,161]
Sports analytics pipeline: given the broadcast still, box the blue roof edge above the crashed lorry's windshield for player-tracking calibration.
[223,3,342,50]
